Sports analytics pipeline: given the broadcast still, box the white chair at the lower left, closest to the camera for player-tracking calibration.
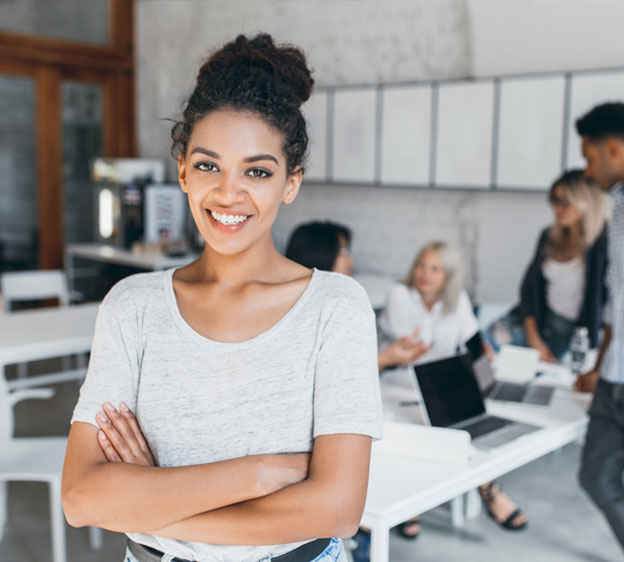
[0,376,103,562]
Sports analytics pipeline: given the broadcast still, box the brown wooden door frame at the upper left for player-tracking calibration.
[0,0,136,269]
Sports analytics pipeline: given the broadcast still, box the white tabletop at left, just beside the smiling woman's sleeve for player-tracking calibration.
[0,303,99,365]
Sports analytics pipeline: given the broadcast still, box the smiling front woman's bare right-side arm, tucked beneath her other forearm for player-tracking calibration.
[151,435,370,545]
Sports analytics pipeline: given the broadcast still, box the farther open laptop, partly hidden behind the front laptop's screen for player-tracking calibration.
[466,332,555,406]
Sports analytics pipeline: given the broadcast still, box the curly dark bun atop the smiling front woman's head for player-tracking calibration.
[197,33,314,105]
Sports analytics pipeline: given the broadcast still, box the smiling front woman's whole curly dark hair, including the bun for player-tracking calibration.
[171,33,314,174]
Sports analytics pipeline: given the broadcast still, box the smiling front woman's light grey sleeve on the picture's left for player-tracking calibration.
[71,299,140,425]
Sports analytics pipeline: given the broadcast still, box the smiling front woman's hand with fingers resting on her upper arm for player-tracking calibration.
[96,402,154,466]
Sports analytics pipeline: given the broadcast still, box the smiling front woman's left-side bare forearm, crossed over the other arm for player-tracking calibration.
[62,423,307,532]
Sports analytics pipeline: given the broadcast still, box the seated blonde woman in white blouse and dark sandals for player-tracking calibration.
[380,241,527,539]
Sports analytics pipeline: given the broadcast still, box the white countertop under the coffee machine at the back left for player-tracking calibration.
[65,244,197,271]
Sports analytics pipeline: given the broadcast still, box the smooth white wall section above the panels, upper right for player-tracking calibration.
[468,0,624,76]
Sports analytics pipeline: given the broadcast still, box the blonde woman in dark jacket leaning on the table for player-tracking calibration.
[489,170,610,362]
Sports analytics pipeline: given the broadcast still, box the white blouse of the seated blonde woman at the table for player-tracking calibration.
[379,283,479,362]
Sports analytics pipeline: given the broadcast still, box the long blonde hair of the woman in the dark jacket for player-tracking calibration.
[548,166,611,255]
